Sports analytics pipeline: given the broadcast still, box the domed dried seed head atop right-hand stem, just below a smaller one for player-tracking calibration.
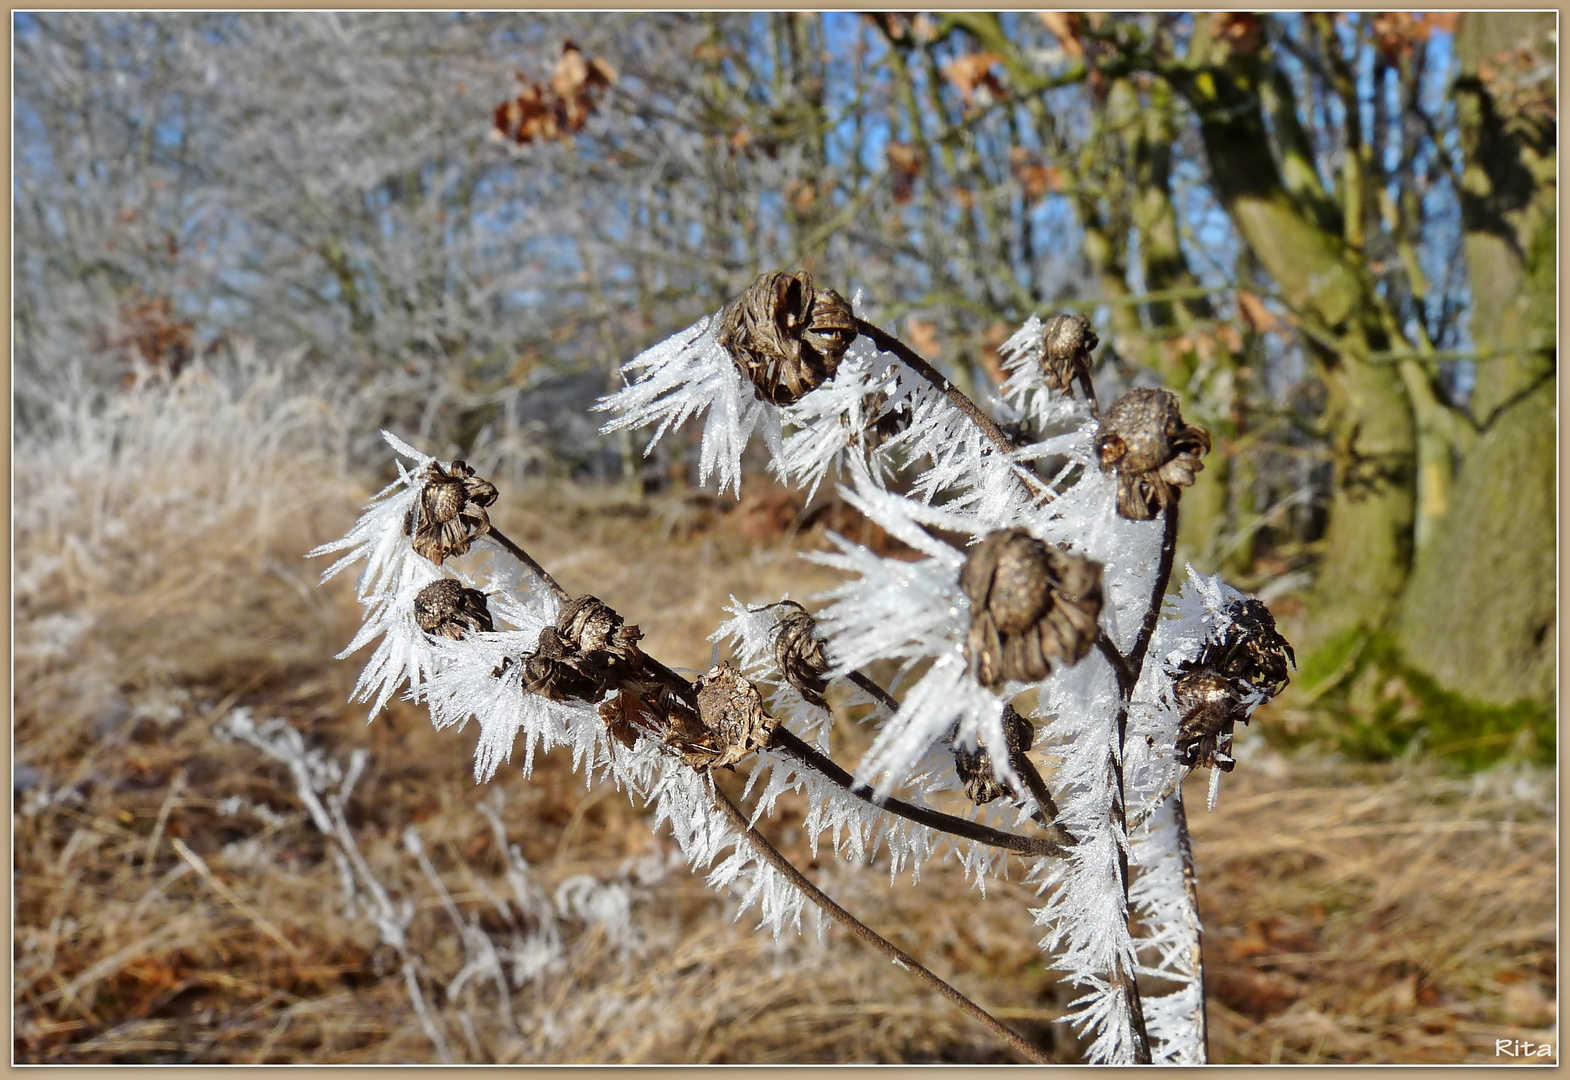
[1096,388,1210,521]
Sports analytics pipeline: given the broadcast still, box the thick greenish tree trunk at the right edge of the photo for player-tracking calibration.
[1397,13,1557,705]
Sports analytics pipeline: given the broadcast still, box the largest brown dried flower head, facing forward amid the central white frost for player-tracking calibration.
[959,529,1102,691]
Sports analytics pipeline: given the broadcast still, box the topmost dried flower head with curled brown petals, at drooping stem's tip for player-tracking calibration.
[716,270,856,405]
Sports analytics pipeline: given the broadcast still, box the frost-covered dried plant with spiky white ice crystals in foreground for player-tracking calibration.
[312,273,1291,1063]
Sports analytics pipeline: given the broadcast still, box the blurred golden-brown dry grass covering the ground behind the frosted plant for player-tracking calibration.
[13,375,1556,1063]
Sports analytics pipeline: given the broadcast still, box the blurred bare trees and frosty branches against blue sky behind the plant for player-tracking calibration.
[13,13,1557,764]
